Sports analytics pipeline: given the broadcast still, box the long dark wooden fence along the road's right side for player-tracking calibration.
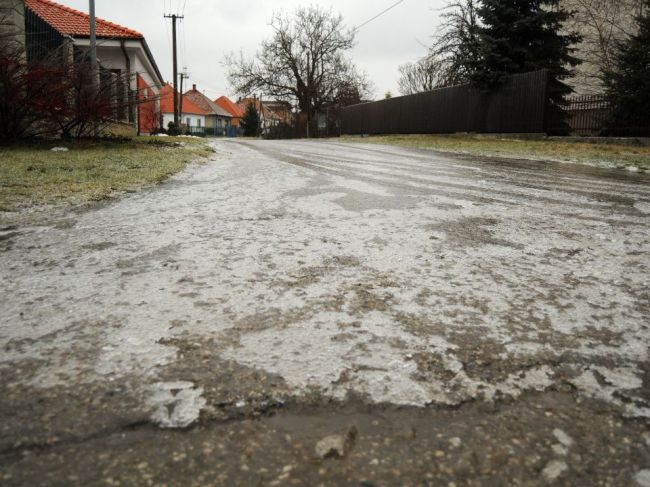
[341,70,548,134]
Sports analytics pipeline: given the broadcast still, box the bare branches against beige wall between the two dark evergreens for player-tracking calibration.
[562,0,643,93]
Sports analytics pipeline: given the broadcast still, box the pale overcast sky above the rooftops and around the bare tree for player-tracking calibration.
[56,0,445,98]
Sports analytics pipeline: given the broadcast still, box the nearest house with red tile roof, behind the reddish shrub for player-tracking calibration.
[25,0,164,133]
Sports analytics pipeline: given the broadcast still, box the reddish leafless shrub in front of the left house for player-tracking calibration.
[0,34,155,141]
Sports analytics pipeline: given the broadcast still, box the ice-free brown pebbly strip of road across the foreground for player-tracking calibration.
[0,393,650,487]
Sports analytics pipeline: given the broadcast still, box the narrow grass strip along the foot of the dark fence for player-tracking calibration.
[343,135,650,170]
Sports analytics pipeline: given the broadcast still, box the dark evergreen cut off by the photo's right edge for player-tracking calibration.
[603,0,650,135]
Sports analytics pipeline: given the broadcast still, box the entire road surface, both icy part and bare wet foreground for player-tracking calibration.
[0,141,650,486]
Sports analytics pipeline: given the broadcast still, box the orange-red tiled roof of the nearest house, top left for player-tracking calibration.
[25,0,144,39]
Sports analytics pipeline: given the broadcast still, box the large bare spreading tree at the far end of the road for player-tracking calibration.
[225,6,370,117]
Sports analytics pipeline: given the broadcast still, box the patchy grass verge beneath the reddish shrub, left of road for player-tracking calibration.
[0,137,213,212]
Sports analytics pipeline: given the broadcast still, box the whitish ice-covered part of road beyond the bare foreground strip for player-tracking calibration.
[0,140,650,425]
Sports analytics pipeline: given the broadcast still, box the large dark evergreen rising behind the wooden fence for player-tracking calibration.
[471,0,580,96]
